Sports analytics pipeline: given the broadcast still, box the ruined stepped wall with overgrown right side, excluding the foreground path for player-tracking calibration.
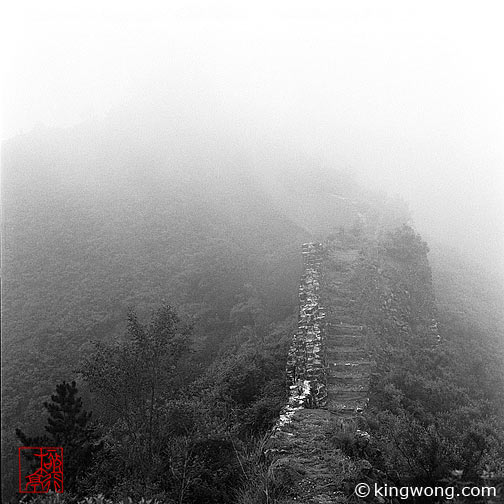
[278,227,440,427]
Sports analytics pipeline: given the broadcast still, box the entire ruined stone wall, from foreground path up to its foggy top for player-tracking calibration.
[266,228,439,504]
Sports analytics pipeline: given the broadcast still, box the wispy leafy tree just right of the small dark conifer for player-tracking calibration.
[81,305,191,482]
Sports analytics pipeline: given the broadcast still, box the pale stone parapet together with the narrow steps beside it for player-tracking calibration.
[279,243,371,427]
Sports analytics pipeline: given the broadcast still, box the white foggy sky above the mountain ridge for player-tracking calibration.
[1,1,504,275]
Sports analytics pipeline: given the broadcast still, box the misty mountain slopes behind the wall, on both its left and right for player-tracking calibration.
[2,115,504,500]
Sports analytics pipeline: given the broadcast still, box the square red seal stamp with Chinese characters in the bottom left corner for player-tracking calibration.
[18,446,63,493]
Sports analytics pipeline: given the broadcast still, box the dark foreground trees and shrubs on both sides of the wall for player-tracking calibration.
[9,227,504,504]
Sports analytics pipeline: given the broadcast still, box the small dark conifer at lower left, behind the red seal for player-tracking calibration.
[16,381,103,493]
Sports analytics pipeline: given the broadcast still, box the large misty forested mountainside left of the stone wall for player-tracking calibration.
[2,116,370,438]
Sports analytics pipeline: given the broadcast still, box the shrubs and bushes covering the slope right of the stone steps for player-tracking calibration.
[350,227,504,502]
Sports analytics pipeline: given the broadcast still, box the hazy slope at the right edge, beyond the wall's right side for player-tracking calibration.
[430,245,504,415]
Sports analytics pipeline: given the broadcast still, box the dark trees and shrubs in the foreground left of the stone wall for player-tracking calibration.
[5,305,287,503]
